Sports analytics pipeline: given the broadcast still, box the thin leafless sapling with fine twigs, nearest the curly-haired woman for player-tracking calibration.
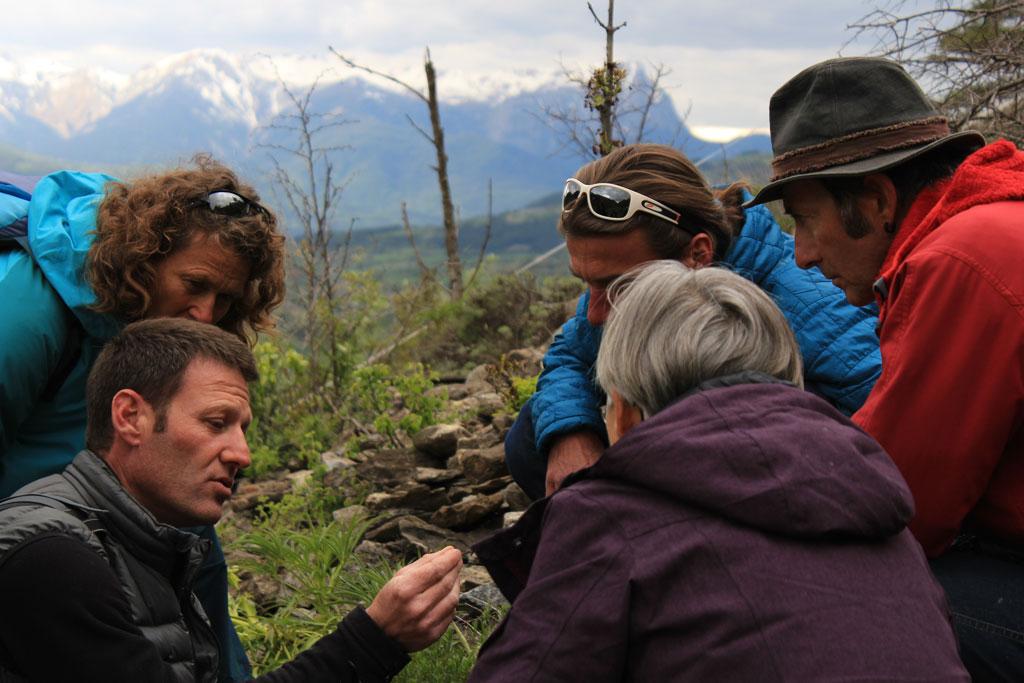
[257,67,355,391]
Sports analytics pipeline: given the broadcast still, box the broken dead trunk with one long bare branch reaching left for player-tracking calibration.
[329,47,464,300]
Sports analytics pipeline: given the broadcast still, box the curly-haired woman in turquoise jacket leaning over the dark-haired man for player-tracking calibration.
[0,156,284,680]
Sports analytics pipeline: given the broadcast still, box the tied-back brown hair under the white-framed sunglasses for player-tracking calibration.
[558,143,746,260]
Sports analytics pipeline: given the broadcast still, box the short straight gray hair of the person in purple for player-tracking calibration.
[597,261,804,417]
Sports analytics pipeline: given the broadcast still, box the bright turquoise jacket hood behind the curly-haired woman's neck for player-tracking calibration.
[29,171,121,339]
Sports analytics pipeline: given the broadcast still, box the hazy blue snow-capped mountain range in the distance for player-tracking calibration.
[0,50,770,227]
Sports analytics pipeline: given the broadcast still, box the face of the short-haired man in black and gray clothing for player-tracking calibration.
[118,358,252,526]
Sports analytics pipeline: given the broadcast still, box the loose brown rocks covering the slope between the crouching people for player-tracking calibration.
[222,349,542,612]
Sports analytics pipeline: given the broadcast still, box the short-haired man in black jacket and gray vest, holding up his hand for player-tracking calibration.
[0,318,462,683]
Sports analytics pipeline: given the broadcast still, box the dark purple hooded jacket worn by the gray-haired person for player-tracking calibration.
[470,376,970,683]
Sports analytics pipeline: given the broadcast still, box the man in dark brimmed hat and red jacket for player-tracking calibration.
[750,57,1024,680]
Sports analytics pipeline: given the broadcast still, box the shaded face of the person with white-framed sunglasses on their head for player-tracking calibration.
[565,229,658,325]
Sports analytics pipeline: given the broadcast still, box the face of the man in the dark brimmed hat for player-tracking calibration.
[782,180,891,306]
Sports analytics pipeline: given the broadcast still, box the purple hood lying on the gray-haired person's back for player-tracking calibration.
[583,377,913,539]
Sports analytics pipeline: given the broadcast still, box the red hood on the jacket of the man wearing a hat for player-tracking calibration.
[881,140,1024,294]
